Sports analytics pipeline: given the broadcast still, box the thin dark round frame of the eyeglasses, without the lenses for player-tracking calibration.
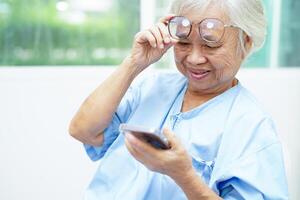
[167,15,241,43]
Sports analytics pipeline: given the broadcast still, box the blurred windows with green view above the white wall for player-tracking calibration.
[0,0,300,68]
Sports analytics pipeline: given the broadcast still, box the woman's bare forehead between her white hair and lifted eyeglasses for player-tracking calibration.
[181,4,230,24]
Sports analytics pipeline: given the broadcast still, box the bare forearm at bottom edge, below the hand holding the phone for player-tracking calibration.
[174,170,222,200]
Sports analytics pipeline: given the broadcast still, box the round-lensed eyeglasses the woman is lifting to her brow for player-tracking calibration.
[168,16,239,45]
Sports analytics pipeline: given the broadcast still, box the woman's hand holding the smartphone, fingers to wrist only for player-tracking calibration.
[125,129,194,181]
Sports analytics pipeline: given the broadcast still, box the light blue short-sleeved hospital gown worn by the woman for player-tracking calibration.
[84,73,288,200]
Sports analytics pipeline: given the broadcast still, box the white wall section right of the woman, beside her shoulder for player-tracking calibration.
[239,68,300,200]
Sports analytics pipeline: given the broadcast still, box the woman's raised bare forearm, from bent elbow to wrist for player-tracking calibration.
[70,59,139,145]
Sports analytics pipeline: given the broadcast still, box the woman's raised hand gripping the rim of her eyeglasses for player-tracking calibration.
[130,15,176,71]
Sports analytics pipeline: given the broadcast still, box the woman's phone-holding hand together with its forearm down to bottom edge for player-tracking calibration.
[125,129,221,200]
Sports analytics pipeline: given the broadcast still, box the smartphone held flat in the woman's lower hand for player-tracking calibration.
[119,124,171,149]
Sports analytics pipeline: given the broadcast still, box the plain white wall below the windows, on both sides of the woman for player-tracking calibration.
[0,67,300,200]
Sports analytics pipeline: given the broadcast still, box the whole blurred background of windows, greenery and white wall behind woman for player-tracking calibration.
[0,0,300,200]
